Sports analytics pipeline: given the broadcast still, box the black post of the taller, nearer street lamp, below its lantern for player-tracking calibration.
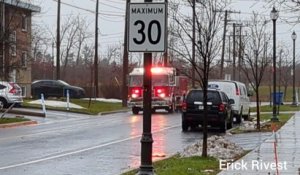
[271,19,279,122]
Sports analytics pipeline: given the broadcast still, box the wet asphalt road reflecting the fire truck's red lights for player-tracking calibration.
[0,108,268,175]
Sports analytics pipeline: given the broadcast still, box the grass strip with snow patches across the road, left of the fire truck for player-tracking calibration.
[22,99,128,115]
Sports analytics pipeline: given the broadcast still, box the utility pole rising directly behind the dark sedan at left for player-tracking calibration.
[56,0,60,80]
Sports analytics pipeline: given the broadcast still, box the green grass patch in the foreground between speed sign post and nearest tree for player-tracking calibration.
[123,155,220,175]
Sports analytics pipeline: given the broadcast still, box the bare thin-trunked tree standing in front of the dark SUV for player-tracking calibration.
[170,0,228,157]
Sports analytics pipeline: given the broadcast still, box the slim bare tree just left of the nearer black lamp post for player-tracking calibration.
[242,13,272,130]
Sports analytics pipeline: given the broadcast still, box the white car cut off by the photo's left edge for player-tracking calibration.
[0,81,23,109]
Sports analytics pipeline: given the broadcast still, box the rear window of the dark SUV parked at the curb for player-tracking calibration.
[187,90,221,104]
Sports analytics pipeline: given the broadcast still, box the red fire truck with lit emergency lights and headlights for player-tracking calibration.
[128,67,188,114]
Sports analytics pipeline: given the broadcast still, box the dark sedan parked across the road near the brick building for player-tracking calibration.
[31,80,85,98]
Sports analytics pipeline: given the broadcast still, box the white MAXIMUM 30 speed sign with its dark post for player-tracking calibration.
[127,0,167,175]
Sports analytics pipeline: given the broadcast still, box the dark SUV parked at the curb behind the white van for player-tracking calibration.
[182,89,234,132]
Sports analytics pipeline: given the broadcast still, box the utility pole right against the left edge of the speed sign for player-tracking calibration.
[122,0,130,107]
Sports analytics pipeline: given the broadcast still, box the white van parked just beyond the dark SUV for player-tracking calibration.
[208,80,252,123]
